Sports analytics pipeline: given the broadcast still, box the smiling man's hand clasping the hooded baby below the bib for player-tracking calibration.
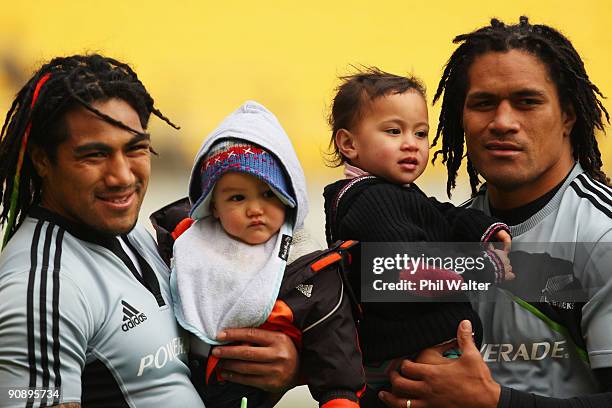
[213,328,298,393]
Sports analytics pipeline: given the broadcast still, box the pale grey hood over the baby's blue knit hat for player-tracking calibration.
[189,101,308,229]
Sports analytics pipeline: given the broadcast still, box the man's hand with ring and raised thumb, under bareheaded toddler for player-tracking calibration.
[379,320,501,408]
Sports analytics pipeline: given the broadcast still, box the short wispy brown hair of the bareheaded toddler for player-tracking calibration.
[327,67,425,167]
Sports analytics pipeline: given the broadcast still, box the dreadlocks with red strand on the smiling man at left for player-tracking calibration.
[0,54,178,241]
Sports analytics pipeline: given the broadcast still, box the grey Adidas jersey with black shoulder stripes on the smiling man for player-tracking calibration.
[0,217,203,407]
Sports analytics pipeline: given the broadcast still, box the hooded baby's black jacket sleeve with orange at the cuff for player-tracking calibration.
[300,268,365,407]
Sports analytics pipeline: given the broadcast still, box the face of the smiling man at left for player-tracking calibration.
[31,98,151,235]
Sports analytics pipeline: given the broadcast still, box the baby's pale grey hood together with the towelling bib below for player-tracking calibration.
[170,102,308,344]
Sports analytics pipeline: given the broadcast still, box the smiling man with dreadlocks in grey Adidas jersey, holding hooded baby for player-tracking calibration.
[0,55,295,407]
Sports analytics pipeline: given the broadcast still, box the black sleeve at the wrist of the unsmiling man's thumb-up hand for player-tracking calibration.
[497,387,612,408]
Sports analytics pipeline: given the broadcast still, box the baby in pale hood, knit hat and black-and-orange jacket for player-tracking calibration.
[165,102,364,408]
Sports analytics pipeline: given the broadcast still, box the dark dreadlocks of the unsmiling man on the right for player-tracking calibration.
[432,16,610,197]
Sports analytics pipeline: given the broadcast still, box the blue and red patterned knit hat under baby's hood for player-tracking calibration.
[189,139,296,220]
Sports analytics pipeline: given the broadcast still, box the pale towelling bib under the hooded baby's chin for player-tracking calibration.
[170,217,292,344]
